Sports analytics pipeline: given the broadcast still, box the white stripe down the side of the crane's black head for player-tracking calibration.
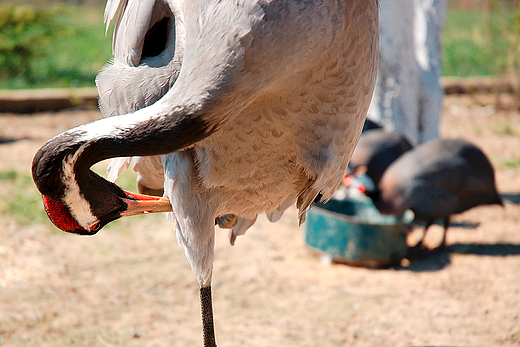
[61,147,98,230]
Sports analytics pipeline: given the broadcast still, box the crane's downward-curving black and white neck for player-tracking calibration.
[32,100,215,201]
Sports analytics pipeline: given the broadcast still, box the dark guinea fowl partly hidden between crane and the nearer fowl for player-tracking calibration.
[348,129,412,186]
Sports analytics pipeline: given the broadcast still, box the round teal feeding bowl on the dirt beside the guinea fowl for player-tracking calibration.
[305,198,414,268]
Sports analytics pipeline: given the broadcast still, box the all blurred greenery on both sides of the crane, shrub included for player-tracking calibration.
[0,0,520,89]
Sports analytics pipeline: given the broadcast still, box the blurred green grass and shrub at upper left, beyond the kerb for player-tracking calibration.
[0,5,111,89]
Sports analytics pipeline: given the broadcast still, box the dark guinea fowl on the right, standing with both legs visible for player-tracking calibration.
[370,139,502,247]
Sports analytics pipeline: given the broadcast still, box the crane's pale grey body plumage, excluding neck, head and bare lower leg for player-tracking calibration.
[97,0,378,286]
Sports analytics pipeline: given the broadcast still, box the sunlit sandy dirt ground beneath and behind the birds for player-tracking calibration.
[0,96,520,347]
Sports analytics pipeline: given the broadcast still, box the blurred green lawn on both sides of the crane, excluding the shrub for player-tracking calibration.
[0,6,520,89]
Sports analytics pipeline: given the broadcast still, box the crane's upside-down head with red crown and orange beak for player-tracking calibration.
[32,132,171,235]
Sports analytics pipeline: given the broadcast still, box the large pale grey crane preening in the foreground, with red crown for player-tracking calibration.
[32,0,379,346]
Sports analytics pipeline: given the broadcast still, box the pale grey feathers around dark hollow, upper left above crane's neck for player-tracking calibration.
[96,0,185,117]
